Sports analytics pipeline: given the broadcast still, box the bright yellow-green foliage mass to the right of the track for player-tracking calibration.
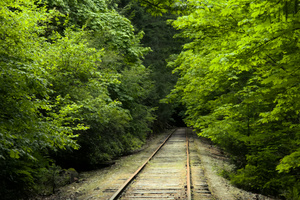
[165,0,300,195]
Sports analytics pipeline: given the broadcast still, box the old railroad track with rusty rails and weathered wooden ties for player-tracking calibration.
[109,128,213,200]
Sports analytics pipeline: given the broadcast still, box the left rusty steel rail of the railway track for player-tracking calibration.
[109,129,177,200]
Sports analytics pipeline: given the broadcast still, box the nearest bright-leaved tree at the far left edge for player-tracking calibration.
[0,0,86,199]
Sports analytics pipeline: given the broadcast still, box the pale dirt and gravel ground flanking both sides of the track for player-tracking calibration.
[35,130,273,200]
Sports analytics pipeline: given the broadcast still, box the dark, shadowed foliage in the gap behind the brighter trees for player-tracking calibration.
[114,0,183,132]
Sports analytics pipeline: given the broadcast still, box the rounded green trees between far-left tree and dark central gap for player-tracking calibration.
[41,1,154,170]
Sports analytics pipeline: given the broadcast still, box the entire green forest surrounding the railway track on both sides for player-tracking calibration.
[0,0,300,200]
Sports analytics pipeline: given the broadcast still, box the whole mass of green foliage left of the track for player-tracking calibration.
[0,0,154,199]
